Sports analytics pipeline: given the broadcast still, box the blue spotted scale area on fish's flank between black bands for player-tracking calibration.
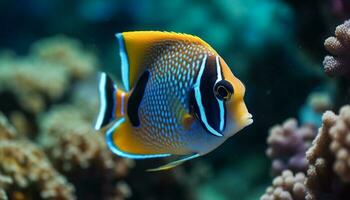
[135,41,214,154]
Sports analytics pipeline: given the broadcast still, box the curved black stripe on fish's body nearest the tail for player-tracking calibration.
[127,71,150,127]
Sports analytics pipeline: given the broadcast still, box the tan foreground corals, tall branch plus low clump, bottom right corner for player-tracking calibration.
[261,105,350,200]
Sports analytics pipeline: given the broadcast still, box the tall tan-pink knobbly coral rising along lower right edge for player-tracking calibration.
[306,106,350,200]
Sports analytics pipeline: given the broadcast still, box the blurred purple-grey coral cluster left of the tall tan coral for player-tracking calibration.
[266,119,317,176]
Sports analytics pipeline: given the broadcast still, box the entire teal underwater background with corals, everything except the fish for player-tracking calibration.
[0,0,350,200]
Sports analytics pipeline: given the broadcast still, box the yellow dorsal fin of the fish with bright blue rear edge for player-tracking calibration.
[116,31,215,91]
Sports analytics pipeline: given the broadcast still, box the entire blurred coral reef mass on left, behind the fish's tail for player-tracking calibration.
[0,36,134,200]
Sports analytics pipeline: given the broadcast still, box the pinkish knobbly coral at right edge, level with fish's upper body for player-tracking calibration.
[323,20,350,76]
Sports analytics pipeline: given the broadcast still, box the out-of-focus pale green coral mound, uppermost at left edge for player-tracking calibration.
[0,36,98,114]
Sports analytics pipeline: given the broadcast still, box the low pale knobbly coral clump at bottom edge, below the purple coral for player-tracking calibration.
[260,170,307,200]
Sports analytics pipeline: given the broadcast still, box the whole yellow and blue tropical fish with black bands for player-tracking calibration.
[95,31,253,171]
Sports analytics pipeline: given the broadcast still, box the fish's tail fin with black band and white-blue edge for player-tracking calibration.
[95,72,128,130]
